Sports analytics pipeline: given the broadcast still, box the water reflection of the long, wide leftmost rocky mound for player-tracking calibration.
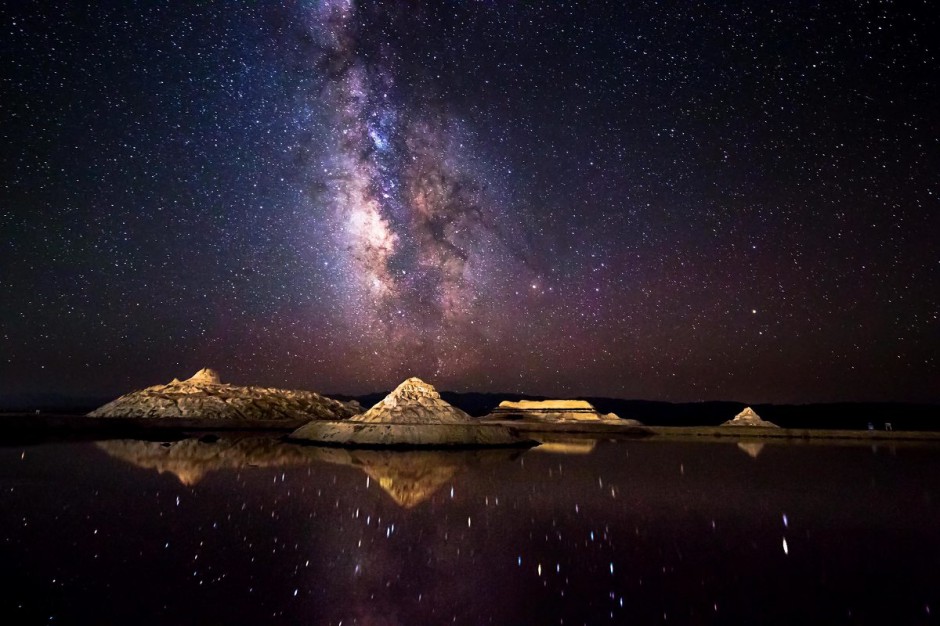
[98,437,309,486]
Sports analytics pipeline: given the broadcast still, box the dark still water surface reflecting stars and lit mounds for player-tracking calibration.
[0,438,940,625]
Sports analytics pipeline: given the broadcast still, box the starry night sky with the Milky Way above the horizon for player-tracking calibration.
[0,0,940,402]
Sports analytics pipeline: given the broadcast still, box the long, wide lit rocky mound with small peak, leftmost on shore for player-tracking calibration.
[88,369,360,421]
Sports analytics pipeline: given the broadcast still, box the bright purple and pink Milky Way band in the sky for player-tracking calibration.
[308,0,532,377]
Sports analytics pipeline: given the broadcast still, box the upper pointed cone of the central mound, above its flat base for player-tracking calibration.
[351,378,473,424]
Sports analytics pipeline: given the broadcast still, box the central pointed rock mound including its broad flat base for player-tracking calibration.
[290,378,534,447]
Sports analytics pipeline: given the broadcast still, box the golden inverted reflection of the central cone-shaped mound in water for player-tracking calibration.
[305,448,520,509]
